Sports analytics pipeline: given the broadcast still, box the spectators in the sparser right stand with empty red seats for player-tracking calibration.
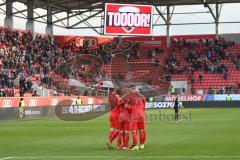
[164,38,240,93]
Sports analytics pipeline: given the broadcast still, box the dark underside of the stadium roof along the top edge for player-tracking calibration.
[14,0,240,12]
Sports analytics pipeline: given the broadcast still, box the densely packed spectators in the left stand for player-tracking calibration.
[0,28,109,96]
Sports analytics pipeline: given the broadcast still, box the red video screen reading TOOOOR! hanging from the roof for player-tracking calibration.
[104,3,153,36]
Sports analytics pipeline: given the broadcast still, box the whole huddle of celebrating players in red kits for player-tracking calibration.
[106,87,146,150]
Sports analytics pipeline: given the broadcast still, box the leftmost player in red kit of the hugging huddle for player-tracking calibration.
[106,89,121,149]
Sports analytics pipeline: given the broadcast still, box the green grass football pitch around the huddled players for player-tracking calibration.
[0,108,240,160]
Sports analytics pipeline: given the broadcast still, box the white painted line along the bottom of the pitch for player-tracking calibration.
[8,156,240,160]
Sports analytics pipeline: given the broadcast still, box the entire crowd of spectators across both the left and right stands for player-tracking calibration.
[0,28,240,96]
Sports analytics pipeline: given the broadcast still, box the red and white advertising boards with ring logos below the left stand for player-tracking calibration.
[0,96,103,108]
